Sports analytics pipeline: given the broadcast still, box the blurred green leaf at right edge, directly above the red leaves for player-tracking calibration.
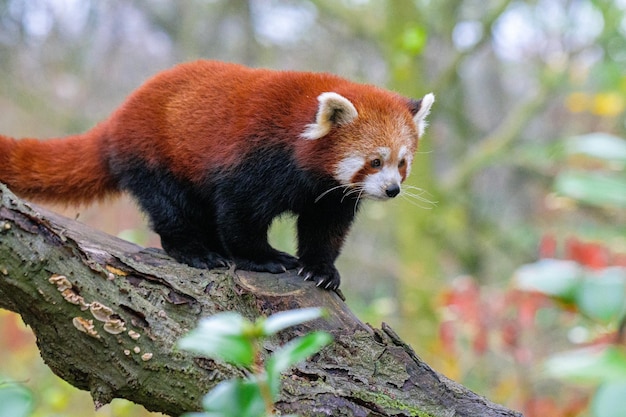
[554,171,626,207]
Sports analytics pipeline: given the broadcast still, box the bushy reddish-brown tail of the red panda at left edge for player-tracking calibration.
[0,127,118,204]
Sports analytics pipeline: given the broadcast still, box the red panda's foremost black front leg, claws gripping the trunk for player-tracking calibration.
[298,202,357,290]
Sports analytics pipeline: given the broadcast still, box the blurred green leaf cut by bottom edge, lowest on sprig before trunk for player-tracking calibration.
[202,379,265,417]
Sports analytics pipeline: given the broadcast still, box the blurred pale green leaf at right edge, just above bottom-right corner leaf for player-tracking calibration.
[545,346,626,384]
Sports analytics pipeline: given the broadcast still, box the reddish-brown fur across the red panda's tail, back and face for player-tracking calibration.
[0,61,417,203]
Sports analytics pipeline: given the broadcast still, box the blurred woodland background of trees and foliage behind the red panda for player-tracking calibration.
[0,0,626,417]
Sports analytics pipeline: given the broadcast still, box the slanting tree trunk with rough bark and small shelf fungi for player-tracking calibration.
[0,185,521,417]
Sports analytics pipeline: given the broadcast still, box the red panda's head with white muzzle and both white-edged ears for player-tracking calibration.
[301,92,435,200]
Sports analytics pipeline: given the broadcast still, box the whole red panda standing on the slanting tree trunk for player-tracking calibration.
[0,61,434,289]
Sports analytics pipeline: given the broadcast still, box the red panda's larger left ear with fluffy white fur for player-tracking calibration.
[300,92,359,139]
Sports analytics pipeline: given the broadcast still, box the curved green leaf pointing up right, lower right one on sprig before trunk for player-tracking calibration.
[266,331,333,396]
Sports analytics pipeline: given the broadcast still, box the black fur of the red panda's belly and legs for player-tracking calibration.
[109,147,358,289]
